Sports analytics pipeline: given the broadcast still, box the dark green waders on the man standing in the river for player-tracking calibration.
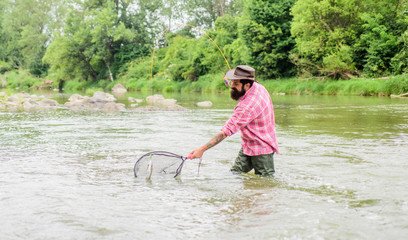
[231,148,275,177]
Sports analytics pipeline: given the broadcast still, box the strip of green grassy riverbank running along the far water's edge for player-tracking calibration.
[2,69,408,96]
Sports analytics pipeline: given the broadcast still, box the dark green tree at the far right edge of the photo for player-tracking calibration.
[353,0,408,76]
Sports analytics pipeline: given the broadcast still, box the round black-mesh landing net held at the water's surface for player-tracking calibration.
[134,151,201,179]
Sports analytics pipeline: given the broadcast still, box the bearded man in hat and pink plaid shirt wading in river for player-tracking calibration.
[187,65,279,176]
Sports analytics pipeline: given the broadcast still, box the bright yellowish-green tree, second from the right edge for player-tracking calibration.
[291,0,362,77]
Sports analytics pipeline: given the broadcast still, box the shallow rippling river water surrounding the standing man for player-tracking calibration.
[0,93,408,239]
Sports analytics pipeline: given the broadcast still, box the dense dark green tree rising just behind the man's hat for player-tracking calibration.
[239,0,295,79]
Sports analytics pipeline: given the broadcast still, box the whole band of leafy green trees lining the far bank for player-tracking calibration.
[0,0,408,94]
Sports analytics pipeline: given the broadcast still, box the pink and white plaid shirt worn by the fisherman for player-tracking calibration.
[221,82,279,156]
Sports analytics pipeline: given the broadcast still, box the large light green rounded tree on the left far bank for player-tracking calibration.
[43,0,157,82]
